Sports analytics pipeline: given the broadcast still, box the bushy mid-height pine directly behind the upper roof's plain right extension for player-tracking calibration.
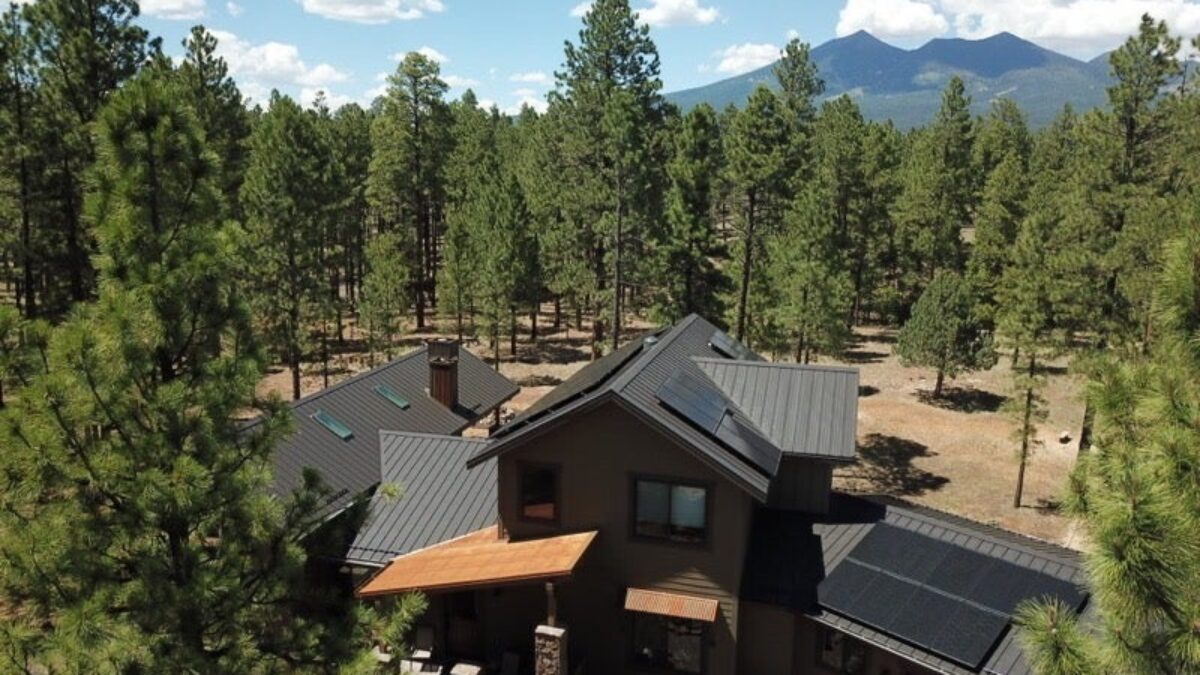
[767,187,853,363]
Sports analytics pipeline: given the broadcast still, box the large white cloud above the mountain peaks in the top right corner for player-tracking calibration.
[937,0,1200,56]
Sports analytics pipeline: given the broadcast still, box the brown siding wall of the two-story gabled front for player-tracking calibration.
[499,404,754,675]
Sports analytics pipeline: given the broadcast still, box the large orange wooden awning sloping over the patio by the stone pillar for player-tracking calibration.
[355,525,596,598]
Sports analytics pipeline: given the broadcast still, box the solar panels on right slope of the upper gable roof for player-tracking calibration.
[656,371,782,476]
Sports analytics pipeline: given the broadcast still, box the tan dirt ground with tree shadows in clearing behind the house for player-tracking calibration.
[262,306,1082,548]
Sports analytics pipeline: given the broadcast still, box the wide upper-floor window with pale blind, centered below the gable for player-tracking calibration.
[634,478,708,544]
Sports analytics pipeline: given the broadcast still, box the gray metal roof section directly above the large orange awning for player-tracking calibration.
[346,431,496,566]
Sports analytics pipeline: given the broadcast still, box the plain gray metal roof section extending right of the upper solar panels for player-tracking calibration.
[696,358,858,461]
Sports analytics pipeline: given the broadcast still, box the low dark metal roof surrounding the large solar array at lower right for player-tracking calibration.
[742,492,1086,675]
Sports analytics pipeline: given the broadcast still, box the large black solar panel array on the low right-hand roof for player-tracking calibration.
[817,524,1086,669]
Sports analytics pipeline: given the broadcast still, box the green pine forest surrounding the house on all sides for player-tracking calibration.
[0,0,1200,674]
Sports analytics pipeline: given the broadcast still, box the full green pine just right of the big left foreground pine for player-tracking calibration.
[241,92,330,399]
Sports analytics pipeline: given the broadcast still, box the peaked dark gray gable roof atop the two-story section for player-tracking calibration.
[472,315,787,501]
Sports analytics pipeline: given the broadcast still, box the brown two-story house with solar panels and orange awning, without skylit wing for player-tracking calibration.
[356,316,1087,675]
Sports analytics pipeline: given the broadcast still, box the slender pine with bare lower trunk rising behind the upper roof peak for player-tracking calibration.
[724,85,790,341]
